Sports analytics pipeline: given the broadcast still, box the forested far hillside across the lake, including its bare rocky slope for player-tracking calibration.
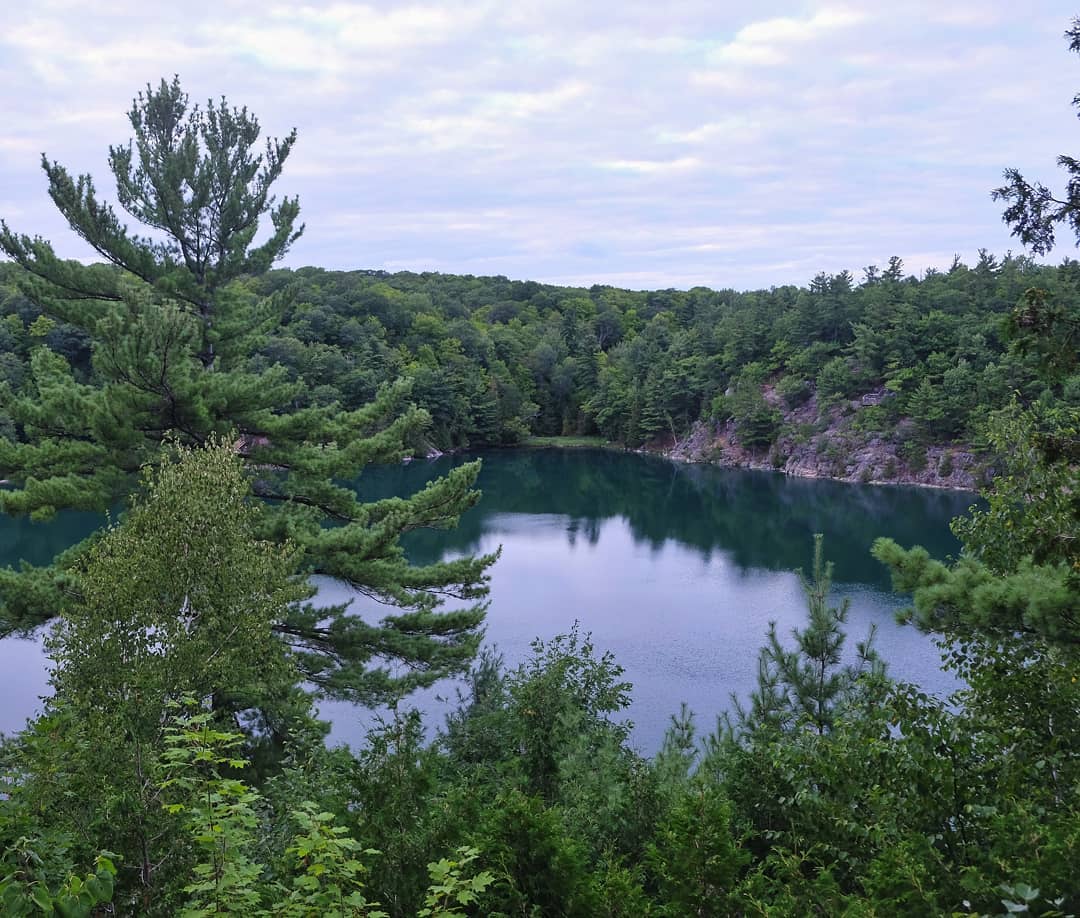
[0,245,1080,483]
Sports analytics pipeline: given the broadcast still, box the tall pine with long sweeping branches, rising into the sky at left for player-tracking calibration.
[0,79,494,702]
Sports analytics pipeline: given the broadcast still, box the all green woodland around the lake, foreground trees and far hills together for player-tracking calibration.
[0,34,1080,918]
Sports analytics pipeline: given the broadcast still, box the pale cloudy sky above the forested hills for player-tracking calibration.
[0,0,1080,289]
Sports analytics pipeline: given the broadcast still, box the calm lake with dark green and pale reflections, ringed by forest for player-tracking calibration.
[0,449,975,753]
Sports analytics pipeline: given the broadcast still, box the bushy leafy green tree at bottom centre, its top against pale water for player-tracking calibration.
[432,629,657,915]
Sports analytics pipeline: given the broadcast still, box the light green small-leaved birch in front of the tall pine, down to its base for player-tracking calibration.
[0,442,310,914]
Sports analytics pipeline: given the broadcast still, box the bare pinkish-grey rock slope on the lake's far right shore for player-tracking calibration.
[661,391,990,490]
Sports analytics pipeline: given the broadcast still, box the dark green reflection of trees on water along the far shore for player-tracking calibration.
[357,449,975,589]
